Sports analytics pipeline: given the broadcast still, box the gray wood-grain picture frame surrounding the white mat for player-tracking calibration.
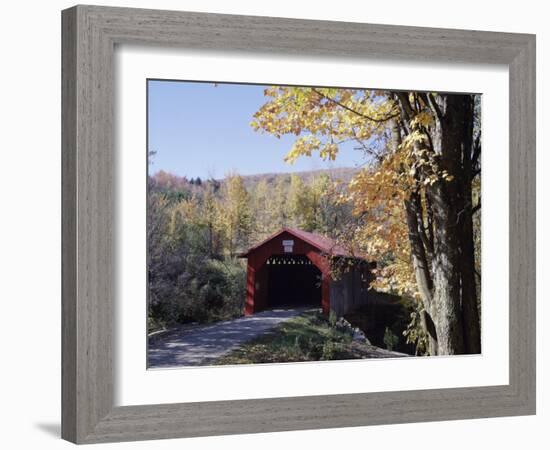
[62,6,535,443]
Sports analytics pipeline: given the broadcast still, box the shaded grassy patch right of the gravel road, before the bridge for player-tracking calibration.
[216,310,363,365]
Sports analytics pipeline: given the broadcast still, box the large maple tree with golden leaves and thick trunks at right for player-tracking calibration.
[251,86,481,355]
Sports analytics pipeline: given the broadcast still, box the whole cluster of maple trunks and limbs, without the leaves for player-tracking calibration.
[394,93,479,355]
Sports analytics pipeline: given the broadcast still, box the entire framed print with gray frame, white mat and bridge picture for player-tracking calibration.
[62,6,535,443]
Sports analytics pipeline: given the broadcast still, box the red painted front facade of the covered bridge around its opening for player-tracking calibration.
[244,231,331,315]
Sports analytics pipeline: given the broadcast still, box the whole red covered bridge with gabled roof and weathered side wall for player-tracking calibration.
[240,228,370,316]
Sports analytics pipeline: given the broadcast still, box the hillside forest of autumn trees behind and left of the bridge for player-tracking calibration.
[148,169,356,329]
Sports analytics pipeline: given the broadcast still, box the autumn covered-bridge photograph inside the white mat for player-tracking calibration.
[144,79,482,369]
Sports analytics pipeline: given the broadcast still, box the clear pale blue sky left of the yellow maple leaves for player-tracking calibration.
[148,80,363,178]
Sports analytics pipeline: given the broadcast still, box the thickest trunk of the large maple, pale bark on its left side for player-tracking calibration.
[428,94,475,354]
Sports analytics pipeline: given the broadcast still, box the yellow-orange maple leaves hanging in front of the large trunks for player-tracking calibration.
[251,86,452,297]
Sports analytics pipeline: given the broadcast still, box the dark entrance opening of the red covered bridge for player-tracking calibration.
[266,255,321,307]
